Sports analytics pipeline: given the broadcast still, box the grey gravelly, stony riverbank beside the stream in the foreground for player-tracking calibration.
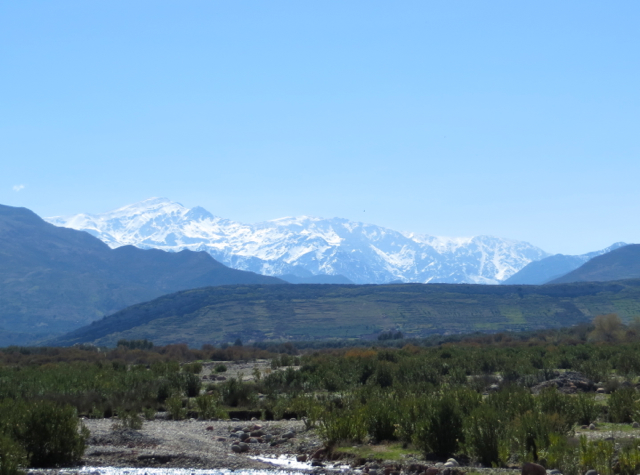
[75,419,321,470]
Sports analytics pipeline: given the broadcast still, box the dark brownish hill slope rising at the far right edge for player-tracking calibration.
[550,244,640,284]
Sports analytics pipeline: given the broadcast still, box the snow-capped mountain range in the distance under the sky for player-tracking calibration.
[46,198,548,284]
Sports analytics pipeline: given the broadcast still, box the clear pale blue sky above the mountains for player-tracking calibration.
[0,0,640,254]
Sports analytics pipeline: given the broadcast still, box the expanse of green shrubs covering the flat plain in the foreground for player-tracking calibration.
[6,314,640,475]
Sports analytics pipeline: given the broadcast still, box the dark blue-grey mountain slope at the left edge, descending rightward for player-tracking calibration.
[0,205,282,346]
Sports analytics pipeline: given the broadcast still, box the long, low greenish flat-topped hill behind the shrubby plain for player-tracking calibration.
[48,280,640,346]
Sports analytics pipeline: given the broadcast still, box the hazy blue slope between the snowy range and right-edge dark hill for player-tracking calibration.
[502,242,627,285]
